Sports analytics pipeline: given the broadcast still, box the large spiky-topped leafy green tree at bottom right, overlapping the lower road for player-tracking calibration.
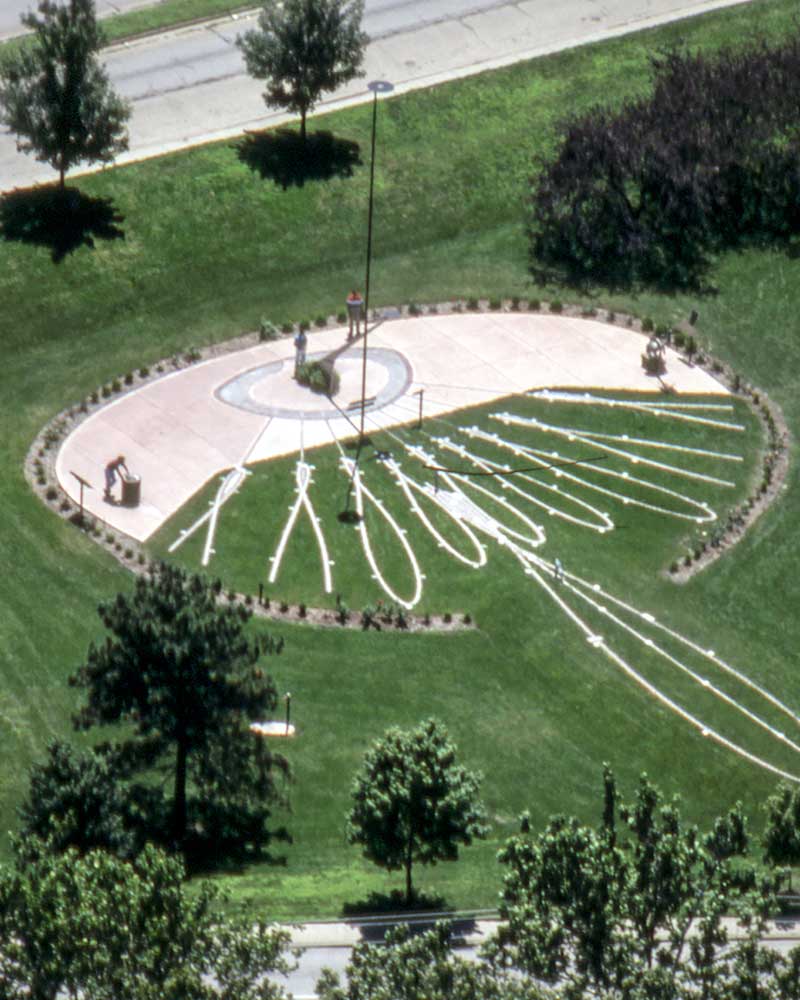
[493,769,775,1000]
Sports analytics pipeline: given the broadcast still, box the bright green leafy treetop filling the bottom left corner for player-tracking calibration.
[0,846,288,1000]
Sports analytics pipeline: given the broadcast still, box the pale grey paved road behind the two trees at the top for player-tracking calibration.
[0,0,749,191]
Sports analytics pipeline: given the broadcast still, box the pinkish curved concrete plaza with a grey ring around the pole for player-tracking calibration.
[56,313,726,542]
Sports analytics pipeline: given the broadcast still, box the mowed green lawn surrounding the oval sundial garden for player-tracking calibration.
[0,0,800,917]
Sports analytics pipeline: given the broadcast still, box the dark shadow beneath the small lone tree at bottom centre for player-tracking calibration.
[342,891,476,943]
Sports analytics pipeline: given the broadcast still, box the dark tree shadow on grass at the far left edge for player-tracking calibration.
[0,186,125,264]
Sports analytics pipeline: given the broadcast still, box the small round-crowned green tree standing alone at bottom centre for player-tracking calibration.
[347,719,486,903]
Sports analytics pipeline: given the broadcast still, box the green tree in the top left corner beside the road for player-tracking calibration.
[0,0,130,190]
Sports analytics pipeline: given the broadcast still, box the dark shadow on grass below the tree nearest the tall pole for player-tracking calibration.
[233,129,362,191]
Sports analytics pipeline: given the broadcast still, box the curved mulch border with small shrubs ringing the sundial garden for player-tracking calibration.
[24,297,790,596]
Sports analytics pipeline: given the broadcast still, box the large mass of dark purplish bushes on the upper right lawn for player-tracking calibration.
[528,34,800,288]
